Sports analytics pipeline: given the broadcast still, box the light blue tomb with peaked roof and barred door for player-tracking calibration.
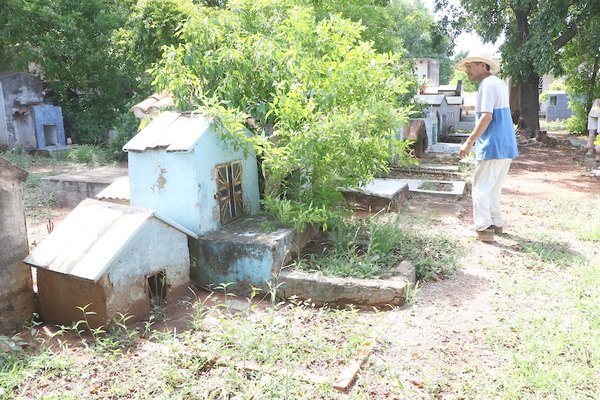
[123,111,260,235]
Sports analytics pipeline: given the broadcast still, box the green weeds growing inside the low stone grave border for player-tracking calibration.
[295,216,462,280]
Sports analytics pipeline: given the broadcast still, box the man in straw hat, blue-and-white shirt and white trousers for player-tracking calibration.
[456,53,518,242]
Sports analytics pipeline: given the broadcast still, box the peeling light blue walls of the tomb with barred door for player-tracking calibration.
[129,116,260,235]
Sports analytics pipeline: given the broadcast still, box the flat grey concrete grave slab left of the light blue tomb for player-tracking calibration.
[41,167,127,207]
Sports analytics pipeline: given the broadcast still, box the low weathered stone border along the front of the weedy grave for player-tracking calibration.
[276,260,416,309]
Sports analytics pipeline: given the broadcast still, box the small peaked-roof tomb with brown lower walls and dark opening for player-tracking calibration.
[24,199,197,327]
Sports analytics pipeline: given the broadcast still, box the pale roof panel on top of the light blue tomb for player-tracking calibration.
[123,111,210,152]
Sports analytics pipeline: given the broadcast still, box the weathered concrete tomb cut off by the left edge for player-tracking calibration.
[0,157,34,332]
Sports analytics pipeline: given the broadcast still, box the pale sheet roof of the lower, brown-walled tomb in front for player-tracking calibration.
[24,199,196,282]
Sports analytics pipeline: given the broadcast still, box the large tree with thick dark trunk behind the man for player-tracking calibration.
[436,0,600,133]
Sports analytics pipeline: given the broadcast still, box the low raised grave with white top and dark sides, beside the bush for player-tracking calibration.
[342,179,408,212]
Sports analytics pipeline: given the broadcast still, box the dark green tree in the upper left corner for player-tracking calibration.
[0,0,131,143]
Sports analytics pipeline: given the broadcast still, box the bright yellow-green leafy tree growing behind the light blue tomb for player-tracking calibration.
[154,0,414,228]
